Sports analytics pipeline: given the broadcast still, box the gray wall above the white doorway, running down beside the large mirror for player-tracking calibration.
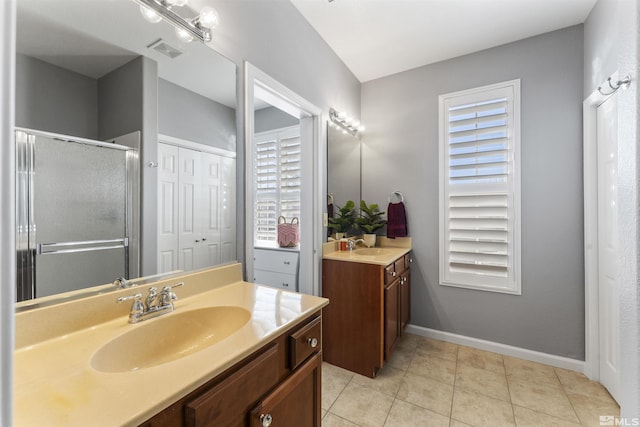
[210,0,360,270]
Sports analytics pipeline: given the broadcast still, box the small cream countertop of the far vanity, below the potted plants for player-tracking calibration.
[322,237,412,265]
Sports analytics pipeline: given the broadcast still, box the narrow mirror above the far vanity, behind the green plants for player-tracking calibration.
[327,113,362,241]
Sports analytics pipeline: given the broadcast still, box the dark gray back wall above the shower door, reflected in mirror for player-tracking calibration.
[16,54,98,139]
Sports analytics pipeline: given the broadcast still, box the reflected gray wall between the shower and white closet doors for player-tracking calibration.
[98,56,158,276]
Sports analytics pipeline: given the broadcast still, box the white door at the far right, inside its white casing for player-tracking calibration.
[596,95,620,401]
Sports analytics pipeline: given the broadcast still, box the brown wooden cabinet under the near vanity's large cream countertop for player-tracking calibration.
[142,313,322,427]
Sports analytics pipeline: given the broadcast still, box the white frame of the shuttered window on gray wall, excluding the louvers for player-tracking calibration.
[438,79,522,295]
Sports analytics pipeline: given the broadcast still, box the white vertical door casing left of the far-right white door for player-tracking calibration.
[582,71,618,381]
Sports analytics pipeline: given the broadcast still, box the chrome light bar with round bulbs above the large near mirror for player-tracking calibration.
[136,0,219,43]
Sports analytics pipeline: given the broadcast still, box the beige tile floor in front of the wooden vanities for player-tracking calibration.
[322,334,620,427]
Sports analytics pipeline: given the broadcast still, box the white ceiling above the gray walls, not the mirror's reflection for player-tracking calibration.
[291,0,597,82]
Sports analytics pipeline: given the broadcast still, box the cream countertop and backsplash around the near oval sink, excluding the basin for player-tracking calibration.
[14,264,328,426]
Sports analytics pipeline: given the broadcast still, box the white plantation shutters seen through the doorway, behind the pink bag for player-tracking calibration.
[254,126,301,245]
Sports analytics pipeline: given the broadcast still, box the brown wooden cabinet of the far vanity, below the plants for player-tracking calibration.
[322,253,411,378]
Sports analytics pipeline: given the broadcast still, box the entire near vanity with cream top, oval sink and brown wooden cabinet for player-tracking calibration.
[14,264,328,426]
